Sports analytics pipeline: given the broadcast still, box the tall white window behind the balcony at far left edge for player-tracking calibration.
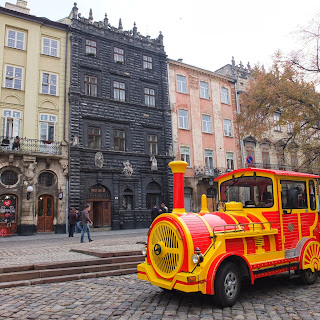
[1,110,21,139]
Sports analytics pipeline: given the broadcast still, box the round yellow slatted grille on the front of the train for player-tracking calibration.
[148,221,183,279]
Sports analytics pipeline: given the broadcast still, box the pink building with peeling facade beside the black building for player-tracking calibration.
[168,59,241,211]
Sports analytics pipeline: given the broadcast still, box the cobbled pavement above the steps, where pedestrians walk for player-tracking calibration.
[0,229,148,266]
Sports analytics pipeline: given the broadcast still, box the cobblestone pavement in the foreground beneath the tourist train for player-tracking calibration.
[0,275,320,320]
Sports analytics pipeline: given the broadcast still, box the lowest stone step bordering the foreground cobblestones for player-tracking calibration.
[0,268,137,289]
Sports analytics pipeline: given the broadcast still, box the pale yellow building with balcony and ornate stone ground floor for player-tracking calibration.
[0,0,70,235]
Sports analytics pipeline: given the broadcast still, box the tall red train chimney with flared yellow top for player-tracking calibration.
[169,161,188,213]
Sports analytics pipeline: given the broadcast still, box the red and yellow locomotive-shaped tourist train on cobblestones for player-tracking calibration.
[137,161,320,307]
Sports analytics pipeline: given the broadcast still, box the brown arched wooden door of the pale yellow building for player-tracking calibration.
[37,195,54,232]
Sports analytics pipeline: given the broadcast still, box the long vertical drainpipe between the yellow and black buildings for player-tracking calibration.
[63,26,70,233]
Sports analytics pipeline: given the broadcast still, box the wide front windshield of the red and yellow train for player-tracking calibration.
[220,176,274,208]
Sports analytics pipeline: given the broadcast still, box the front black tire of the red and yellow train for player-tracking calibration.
[214,262,241,308]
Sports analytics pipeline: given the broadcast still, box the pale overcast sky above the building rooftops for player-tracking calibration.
[0,0,320,71]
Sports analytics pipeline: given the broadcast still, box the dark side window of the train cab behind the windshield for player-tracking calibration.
[280,180,307,209]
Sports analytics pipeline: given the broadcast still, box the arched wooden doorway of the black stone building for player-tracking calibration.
[86,184,111,228]
